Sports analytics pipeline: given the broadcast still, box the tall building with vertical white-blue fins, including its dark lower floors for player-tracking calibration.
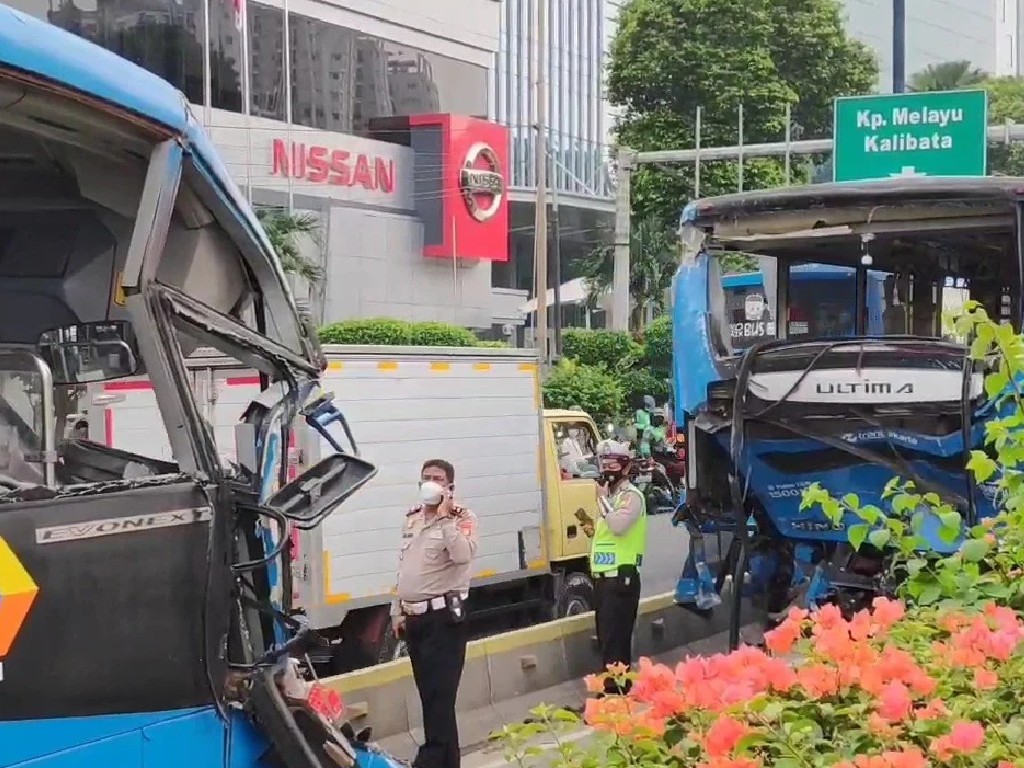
[492,0,613,319]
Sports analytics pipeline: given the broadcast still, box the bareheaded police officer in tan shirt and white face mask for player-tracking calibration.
[391,459,477,768]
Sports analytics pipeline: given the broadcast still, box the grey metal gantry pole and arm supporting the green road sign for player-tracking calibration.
[609,121,1024,331]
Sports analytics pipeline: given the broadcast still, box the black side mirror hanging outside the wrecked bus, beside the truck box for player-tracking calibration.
[264,454,377,530]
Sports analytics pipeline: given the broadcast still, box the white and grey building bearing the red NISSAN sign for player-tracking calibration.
[12,0,516,331]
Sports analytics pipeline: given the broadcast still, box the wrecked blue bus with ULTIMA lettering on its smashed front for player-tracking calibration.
[674,177,1024,640]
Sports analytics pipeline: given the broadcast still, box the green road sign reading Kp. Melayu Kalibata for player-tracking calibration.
[833,90,988,181]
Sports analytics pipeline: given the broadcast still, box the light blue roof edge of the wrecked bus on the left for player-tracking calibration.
[0,5,188,134]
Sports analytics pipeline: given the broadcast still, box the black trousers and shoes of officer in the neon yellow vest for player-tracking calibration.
[594,565,640,693]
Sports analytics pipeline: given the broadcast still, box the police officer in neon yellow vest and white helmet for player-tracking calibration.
[584,439,647,693]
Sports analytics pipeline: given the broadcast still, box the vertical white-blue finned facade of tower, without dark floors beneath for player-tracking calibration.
[492,0,611,198]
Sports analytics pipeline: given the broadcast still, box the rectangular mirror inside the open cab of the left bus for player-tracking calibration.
[37,321,138,384]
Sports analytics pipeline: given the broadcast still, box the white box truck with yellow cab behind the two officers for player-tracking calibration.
[88,345,599,671]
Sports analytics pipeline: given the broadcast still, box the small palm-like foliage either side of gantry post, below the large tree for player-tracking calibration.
[577,216,679,328]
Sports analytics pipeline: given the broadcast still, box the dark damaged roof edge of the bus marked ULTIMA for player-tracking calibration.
[680,176,1024,227]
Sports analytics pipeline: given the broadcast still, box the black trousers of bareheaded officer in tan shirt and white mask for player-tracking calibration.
[406,608,468,768]
